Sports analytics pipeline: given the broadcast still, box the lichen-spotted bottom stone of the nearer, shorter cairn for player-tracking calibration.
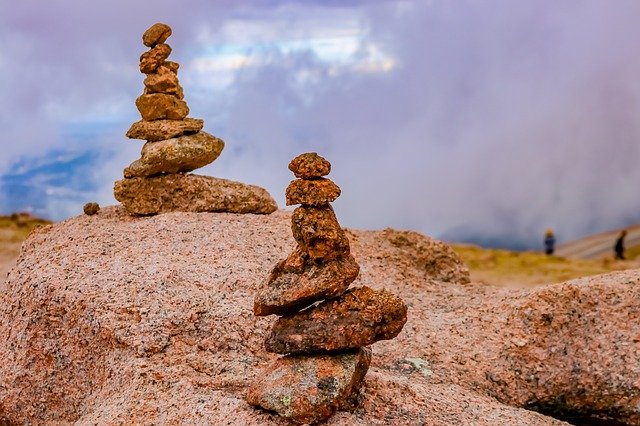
[247,348,371,424]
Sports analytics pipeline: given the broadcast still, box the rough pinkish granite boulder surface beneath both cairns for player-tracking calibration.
[0,207,640,425]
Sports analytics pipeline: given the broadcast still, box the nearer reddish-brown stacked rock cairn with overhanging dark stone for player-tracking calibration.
[247,153,407,424]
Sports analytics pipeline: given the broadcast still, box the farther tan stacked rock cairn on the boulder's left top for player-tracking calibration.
[114,23,277,215]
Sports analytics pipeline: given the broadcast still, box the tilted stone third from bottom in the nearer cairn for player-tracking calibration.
[253,248,360,316]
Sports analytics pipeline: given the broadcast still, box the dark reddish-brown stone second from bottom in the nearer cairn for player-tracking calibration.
[265,287,407,354]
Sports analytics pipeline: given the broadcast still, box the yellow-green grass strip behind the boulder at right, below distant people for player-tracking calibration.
[453,245,640,286]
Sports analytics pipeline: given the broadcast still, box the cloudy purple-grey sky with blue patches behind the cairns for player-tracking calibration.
[0,0,640,248]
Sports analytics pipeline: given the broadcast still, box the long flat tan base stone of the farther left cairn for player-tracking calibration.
[113,174,278,215]
